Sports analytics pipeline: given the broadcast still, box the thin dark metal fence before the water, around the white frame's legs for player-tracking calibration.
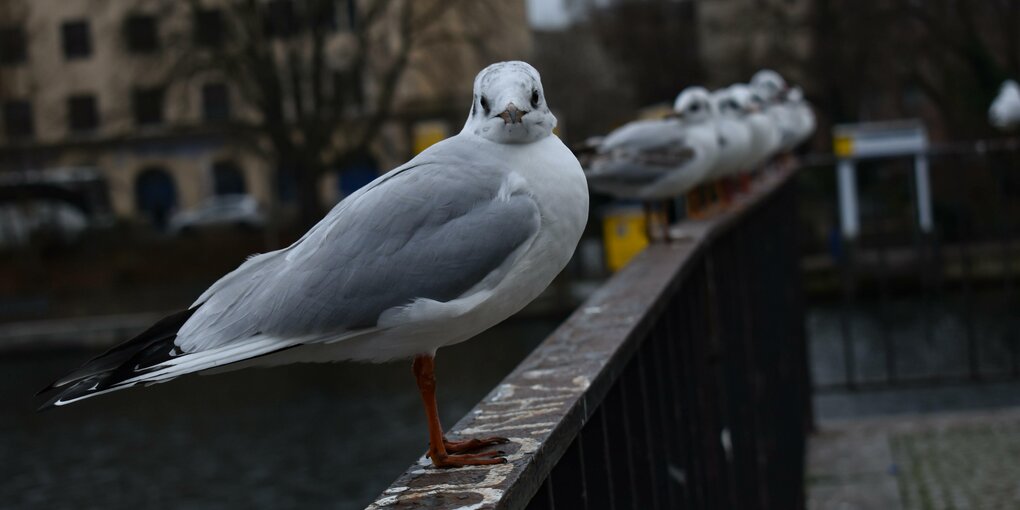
[805,141,1020,391]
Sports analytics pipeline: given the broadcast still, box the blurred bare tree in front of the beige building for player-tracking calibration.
[163,0,494,225]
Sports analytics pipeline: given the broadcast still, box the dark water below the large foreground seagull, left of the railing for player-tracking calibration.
[0,319,558,509]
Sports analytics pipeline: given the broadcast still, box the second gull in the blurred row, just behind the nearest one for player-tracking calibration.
[710,89,753,177]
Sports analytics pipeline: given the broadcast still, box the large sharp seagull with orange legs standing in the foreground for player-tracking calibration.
[37,61,589,467]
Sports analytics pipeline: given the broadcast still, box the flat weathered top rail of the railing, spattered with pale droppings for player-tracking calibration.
[368,165,794,509]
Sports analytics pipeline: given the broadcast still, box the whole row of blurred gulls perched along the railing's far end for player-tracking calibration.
[585,69,815,207]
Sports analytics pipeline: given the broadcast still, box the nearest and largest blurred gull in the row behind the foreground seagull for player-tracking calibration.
[588,87,719,200]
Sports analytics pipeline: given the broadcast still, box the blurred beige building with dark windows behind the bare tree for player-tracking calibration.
[0,0,530,227]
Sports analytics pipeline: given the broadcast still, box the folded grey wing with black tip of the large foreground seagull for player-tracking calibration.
[44,139,541,407]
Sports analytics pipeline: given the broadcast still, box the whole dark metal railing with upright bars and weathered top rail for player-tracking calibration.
[369,168,810,510]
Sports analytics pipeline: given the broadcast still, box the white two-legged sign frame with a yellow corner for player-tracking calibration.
[832,120,934,239]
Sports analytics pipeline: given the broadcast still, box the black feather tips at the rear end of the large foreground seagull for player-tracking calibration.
[37,306,198,411]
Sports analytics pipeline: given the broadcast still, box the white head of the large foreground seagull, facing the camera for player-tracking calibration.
[462,61,556,144]
